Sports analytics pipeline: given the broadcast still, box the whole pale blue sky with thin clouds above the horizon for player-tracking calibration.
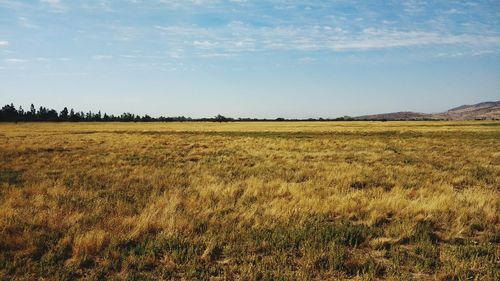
[0,0,500,118]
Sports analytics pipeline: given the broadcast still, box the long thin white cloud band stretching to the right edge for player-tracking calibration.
[156,24,500,53]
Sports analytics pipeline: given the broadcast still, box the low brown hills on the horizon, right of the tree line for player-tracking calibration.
[354,101,500,120]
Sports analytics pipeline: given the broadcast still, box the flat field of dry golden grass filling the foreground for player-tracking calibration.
[0,121,500,280]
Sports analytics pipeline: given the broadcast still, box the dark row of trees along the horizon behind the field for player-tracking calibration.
[0,103,352,122]
